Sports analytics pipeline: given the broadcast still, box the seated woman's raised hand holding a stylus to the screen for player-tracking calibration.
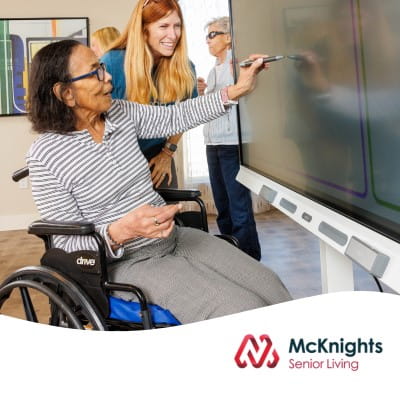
[228,54,269,100]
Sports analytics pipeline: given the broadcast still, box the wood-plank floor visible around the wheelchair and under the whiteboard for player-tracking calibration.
[0,209,388,316]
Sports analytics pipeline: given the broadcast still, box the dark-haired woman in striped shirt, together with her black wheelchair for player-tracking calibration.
[0,40,291,329]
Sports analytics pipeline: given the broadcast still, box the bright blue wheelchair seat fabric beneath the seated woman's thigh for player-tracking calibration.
[109,296,181,325]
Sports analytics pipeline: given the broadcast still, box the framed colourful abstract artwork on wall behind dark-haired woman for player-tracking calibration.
[0,17,89,116]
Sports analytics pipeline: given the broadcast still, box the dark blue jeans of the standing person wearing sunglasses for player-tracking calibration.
[206,145,261,260]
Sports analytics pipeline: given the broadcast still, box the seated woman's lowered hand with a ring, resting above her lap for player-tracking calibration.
[108,204,182,243]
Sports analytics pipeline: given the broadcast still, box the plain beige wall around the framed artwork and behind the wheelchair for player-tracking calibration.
[0,0,136,231]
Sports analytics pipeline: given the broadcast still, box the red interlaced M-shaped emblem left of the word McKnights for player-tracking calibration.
[235,335,279,368]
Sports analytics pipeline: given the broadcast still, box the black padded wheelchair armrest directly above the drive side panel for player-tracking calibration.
[28,220,95,236]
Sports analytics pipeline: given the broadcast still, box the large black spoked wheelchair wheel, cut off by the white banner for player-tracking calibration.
[0,266,107,330]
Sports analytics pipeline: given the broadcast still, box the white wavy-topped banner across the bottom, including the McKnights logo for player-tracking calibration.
[0,292,400,400]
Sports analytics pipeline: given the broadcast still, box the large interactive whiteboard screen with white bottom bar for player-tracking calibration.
[231,0,400,290]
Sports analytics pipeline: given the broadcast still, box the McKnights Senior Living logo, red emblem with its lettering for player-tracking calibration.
[235,334,383,372]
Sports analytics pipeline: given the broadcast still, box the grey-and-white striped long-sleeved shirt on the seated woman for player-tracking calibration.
[27,92,226,258]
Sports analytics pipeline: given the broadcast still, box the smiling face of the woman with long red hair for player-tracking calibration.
[146,11,182,62]
